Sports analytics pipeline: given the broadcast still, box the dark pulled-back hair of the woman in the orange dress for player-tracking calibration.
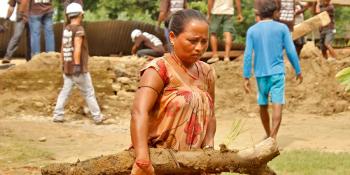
[169,9,209,36]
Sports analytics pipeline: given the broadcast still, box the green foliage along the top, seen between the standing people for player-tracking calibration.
[54,0,350,43]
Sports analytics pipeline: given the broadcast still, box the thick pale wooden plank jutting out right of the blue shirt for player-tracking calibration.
[292,12,331,40]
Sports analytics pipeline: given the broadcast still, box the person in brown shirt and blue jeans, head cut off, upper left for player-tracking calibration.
[29,0,55,56]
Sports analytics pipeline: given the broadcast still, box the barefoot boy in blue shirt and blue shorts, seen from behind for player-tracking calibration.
[243,0,303,139]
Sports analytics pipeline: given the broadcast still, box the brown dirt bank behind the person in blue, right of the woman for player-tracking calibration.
[214,50,350,116]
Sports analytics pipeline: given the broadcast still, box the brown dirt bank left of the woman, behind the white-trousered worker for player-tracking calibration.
[0,53,145,119]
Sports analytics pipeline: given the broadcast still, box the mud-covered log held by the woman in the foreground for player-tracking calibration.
[41,138,279,175]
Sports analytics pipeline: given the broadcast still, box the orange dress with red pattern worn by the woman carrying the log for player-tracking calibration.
[141,55,215,150]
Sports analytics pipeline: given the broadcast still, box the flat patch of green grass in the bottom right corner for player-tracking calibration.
[222,150,350,175]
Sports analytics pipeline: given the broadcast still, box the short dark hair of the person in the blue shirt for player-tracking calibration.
[257,0,278,18]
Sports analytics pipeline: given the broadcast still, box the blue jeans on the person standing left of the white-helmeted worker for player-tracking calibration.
[29,13,55,56]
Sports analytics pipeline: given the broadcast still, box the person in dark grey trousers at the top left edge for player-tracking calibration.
[2,0,31,64]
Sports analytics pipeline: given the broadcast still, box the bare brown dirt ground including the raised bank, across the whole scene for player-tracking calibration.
[0,45,350,175]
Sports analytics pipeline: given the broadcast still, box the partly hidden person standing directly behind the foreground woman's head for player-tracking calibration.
[157,0,187,52]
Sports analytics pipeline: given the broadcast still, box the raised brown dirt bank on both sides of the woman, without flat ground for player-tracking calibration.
[0,49,350,119]
